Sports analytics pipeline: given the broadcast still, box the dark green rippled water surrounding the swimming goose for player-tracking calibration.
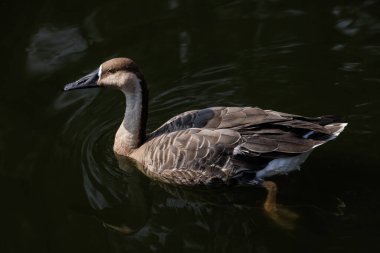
[0,0,380,253]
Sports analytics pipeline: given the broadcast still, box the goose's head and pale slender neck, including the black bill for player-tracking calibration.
[64,58,148,154]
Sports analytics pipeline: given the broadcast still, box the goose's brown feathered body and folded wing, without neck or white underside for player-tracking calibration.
[137,107,346,185]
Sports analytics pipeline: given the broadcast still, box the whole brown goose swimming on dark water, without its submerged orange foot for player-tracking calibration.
[64,58,347,188]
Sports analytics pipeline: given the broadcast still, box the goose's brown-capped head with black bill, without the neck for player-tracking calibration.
[64,58,143,93]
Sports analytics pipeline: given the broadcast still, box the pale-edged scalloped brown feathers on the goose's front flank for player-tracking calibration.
[142,128,241,183]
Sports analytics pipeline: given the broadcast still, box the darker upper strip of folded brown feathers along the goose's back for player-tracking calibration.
[147,107,336,140]
